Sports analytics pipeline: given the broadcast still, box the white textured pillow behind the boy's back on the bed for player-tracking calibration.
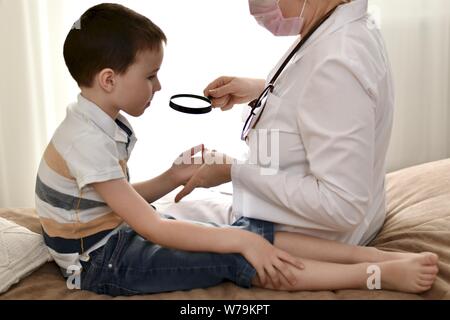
[0,218,52,293]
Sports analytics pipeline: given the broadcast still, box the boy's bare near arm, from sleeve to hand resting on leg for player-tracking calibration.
[92,179,302,282]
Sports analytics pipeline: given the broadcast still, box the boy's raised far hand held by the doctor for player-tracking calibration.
[169,144,205,186]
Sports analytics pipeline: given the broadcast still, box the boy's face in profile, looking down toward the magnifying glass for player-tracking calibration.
[114,46,164,117]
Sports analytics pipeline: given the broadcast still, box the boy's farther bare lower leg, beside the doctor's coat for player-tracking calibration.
[274,232,424,264]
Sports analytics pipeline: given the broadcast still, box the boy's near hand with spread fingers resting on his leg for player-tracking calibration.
[242,234,305,288]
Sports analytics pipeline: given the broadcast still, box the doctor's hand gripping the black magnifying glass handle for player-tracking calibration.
[203,77,265,111]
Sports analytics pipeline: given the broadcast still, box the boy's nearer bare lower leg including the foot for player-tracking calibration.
[253,253,438,293]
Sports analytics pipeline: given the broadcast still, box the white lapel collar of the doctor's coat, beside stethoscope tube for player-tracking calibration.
[292,0,368,62]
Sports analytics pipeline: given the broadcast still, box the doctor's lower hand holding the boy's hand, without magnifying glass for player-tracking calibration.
[175,150,235,202]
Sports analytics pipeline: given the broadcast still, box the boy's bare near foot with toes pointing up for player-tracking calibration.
[379,252,439,293]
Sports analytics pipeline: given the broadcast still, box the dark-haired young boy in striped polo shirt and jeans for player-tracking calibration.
[36,4,437,295]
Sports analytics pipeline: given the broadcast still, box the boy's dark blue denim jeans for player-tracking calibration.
[81,217,274,296]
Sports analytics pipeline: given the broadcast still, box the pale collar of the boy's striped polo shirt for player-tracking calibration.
[71,93,136,143]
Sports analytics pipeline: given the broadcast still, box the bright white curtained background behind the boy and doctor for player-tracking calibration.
[0,0,450,207]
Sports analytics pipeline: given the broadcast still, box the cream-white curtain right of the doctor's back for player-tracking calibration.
[370,0,450,171]
